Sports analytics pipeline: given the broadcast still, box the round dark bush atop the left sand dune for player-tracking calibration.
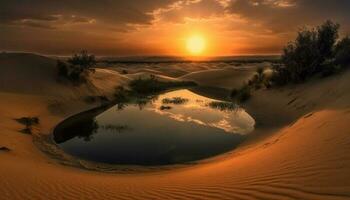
[57,50,97,84]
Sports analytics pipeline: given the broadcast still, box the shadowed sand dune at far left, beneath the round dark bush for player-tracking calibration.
[0,53,129,98]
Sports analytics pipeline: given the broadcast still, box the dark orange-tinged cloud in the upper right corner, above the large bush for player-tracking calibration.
[228,0,350,32]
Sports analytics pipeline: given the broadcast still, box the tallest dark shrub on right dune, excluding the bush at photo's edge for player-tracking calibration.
[274,21,339,84]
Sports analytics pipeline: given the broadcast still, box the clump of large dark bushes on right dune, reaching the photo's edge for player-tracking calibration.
[271,21,350,85]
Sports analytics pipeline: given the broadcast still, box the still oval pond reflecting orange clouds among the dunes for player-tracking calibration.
[54,89,255,166]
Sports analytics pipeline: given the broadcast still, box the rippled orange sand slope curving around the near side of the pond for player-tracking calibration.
[0,54,350,200]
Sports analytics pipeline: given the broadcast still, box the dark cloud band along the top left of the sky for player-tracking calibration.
[0,0,175,25]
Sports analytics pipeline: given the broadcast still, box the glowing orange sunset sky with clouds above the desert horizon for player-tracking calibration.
[0,0,350,56]
